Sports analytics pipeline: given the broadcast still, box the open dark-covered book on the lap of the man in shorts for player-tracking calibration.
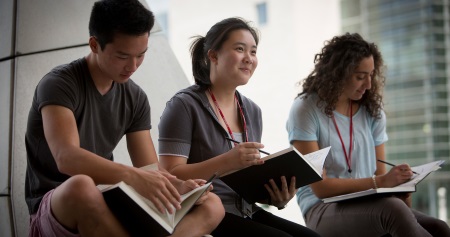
[97,165,211,236]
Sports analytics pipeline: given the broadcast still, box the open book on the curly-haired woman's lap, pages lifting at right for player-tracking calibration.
[322,160,444,203]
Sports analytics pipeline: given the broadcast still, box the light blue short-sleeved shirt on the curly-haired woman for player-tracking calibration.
[286,94,388,215]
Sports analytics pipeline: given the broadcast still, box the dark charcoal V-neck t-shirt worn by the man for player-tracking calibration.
[25,58,151,214]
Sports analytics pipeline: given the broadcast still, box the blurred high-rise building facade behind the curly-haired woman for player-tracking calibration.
[341,0,450,222]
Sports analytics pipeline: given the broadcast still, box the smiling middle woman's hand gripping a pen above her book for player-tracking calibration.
[225,142,264,170]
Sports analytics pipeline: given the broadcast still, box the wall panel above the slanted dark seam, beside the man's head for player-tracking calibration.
[16,0,158,54]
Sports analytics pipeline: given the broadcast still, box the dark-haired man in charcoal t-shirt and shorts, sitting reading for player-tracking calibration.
[25,0,224,236]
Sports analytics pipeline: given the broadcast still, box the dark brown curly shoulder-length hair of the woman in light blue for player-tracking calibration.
[297,33,385,117]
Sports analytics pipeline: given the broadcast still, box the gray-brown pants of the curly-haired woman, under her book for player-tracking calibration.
[305,196,450,237]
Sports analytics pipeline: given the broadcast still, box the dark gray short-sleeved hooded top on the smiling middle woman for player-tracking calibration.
[158,85,262,216]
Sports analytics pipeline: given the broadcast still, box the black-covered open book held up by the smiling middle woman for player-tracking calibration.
[220,147,330,203]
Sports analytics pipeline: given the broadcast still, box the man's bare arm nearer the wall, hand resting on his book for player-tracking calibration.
[41,105,180,212]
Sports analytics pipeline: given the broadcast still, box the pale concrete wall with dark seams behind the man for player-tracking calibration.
[0,0,189,237]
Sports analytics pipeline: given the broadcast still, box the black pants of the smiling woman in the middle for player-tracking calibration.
[211,210,319,237]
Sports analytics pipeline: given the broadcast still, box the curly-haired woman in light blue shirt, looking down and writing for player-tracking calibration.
[286,33,450,237]
